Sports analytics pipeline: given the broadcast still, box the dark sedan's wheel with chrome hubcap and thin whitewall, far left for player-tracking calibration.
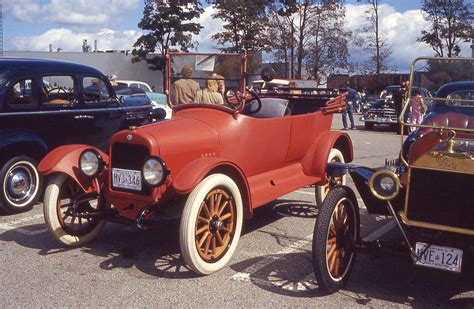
[0,156,42,214]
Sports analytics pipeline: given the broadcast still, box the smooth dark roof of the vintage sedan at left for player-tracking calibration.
[0,57,104,86]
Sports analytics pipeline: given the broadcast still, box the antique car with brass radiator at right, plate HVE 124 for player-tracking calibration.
[313,58,474,292]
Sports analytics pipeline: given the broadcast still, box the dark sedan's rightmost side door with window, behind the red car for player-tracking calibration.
[68,75,122,150]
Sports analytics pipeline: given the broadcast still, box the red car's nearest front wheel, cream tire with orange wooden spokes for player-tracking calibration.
[179,174,243,275]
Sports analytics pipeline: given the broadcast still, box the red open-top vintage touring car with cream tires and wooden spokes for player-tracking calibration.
[39,53,352,274]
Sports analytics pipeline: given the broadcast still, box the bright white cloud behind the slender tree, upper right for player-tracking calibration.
[346,4,470,72]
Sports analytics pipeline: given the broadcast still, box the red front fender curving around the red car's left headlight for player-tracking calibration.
[38,145,109,192]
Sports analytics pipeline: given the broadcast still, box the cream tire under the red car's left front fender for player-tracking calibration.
[43,173,105,247]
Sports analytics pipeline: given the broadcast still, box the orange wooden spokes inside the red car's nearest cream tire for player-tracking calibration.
[194,189,235,262]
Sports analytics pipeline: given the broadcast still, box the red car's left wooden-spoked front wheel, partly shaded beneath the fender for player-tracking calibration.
[43,174,105,247]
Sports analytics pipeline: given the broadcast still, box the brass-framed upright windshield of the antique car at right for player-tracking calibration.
[403,57,474,129]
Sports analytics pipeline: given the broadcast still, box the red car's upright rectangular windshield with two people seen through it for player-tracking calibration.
[167,53,245,109]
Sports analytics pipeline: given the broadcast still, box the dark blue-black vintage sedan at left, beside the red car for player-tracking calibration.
[0,58,159,213]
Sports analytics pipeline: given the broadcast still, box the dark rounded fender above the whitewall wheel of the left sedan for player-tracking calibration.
[0,129,48,161]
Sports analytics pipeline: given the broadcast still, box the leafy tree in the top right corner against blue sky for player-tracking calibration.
[417,0,474,57]
